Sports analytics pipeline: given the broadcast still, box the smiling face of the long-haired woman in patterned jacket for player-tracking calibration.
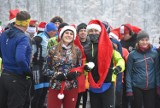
[62,30,74,45]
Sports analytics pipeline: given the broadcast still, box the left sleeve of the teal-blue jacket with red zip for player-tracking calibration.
[126,53,134,92]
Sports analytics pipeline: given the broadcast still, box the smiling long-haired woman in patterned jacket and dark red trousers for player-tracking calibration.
[48,25,83,108]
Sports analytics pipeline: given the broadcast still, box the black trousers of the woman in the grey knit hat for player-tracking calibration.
[133,87,155,108]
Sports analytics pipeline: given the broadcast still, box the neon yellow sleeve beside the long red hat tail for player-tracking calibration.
[113,50,125,72]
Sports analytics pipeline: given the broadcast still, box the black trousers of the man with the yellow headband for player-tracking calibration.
[0,72,28,108]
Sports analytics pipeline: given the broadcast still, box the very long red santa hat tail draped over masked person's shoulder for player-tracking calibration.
[88,20,113,88]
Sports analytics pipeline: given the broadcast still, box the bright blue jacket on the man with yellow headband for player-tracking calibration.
[0,26,31,74]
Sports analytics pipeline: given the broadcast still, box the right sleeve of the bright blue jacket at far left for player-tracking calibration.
[15,36,31,72]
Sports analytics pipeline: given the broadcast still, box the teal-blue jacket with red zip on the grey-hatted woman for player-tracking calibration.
[126,49,160,92]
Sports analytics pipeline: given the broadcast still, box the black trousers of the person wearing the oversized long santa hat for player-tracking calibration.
[89,83,115,108]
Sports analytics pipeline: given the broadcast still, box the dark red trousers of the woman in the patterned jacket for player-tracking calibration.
[48,88,78,108]
